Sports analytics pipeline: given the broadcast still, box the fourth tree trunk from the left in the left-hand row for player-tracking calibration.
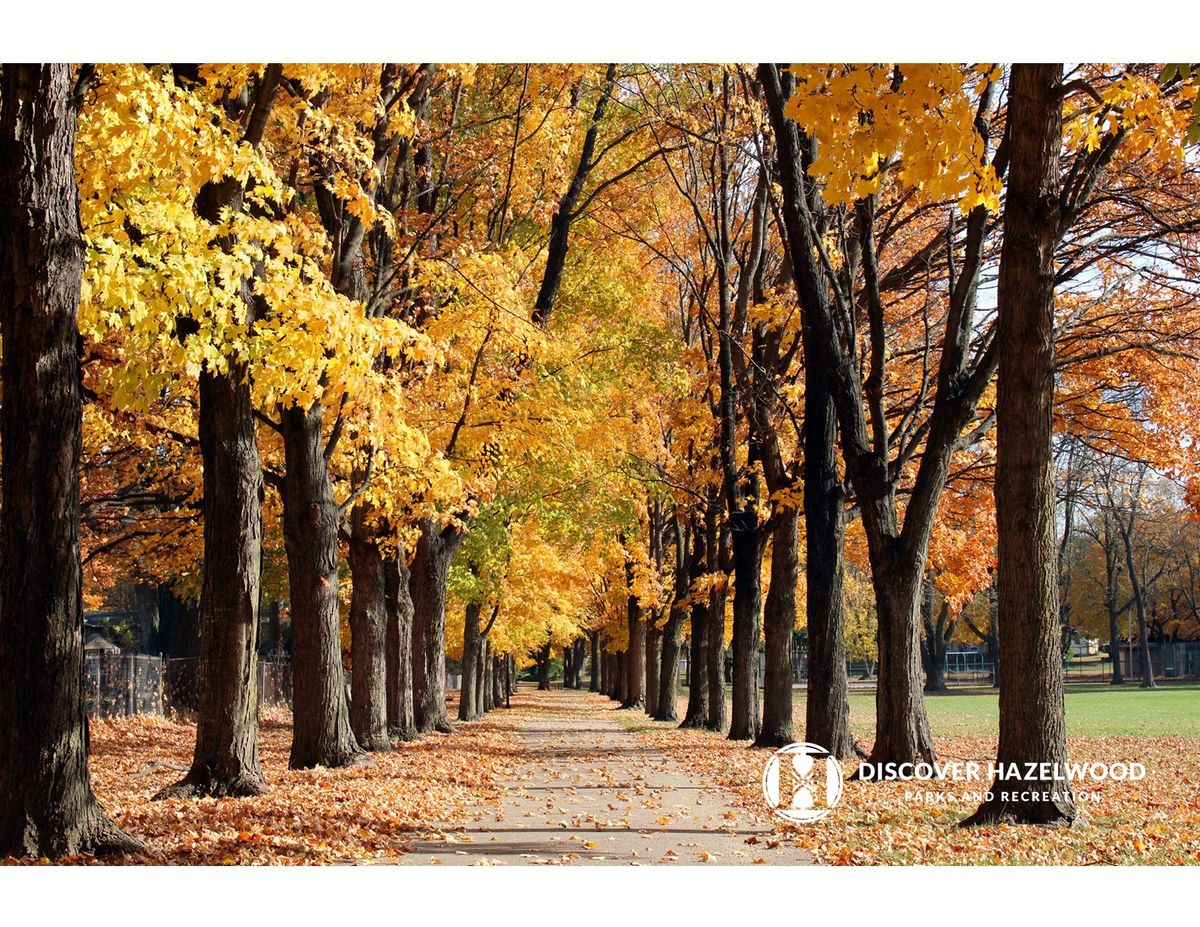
[349,506,391,750]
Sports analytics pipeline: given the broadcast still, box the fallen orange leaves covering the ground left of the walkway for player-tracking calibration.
[21,708,521,865]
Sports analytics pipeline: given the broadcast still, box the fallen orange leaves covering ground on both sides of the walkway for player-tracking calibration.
[11,688,1200,865]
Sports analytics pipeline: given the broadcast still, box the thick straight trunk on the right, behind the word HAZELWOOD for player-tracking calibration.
[965,65,1076,824]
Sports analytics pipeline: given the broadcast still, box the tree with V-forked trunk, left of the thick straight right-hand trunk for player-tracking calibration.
[775,66,1003,768]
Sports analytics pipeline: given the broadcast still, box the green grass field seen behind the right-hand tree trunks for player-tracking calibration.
[796,682,1200,737]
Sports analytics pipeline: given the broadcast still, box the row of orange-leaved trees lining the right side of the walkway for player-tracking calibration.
[561,65,1198,821]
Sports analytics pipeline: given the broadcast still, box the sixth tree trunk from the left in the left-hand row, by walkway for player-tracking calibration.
[409,518,464,734]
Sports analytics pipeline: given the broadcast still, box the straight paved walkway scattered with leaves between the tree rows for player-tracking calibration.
[401,692,809,866]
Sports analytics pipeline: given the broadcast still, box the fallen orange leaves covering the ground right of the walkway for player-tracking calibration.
[635,723,1200,866]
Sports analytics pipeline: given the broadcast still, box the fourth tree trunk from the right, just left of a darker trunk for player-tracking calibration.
[755,509,796,748]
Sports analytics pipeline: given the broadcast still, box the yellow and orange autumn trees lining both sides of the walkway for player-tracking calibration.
[0,64,1200,855]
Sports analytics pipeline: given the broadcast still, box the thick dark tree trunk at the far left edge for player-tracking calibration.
[0,65,144,857]
